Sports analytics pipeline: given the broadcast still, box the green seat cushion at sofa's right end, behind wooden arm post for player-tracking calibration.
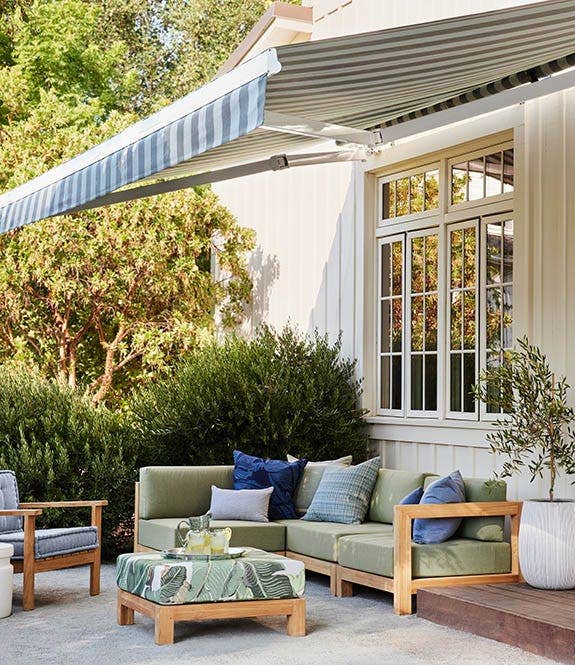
[338,533,511,577]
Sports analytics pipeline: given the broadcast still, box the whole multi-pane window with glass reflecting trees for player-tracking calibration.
[378,145,514,419]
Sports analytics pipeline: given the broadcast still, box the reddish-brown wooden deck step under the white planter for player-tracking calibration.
[417,584,575,664]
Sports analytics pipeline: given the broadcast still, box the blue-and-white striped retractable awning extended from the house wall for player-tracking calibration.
[0,0,575,232]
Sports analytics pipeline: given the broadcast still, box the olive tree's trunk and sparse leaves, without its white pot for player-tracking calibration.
[475,337,575,501]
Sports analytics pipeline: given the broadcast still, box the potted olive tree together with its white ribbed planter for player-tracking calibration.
[474,337,575,589]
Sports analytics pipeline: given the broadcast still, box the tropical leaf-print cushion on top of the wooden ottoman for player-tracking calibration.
[116,550,305,605]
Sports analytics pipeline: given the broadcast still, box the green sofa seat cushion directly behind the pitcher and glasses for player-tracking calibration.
[138,517,285,552]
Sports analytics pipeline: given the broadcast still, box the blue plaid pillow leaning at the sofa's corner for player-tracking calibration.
[302,457,380,524]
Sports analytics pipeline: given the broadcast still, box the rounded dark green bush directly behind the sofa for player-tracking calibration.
[130,327,367,464]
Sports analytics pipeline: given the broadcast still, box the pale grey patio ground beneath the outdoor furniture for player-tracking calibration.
[0,565,553,665]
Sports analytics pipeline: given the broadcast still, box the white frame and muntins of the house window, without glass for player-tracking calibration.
[374,140,517,427]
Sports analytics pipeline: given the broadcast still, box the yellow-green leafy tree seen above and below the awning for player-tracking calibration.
[0,0,253,402]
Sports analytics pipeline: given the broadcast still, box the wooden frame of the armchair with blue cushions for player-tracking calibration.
[0,500,108,610]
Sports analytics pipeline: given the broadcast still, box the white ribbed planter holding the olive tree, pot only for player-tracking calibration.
[519,501,575,589]
